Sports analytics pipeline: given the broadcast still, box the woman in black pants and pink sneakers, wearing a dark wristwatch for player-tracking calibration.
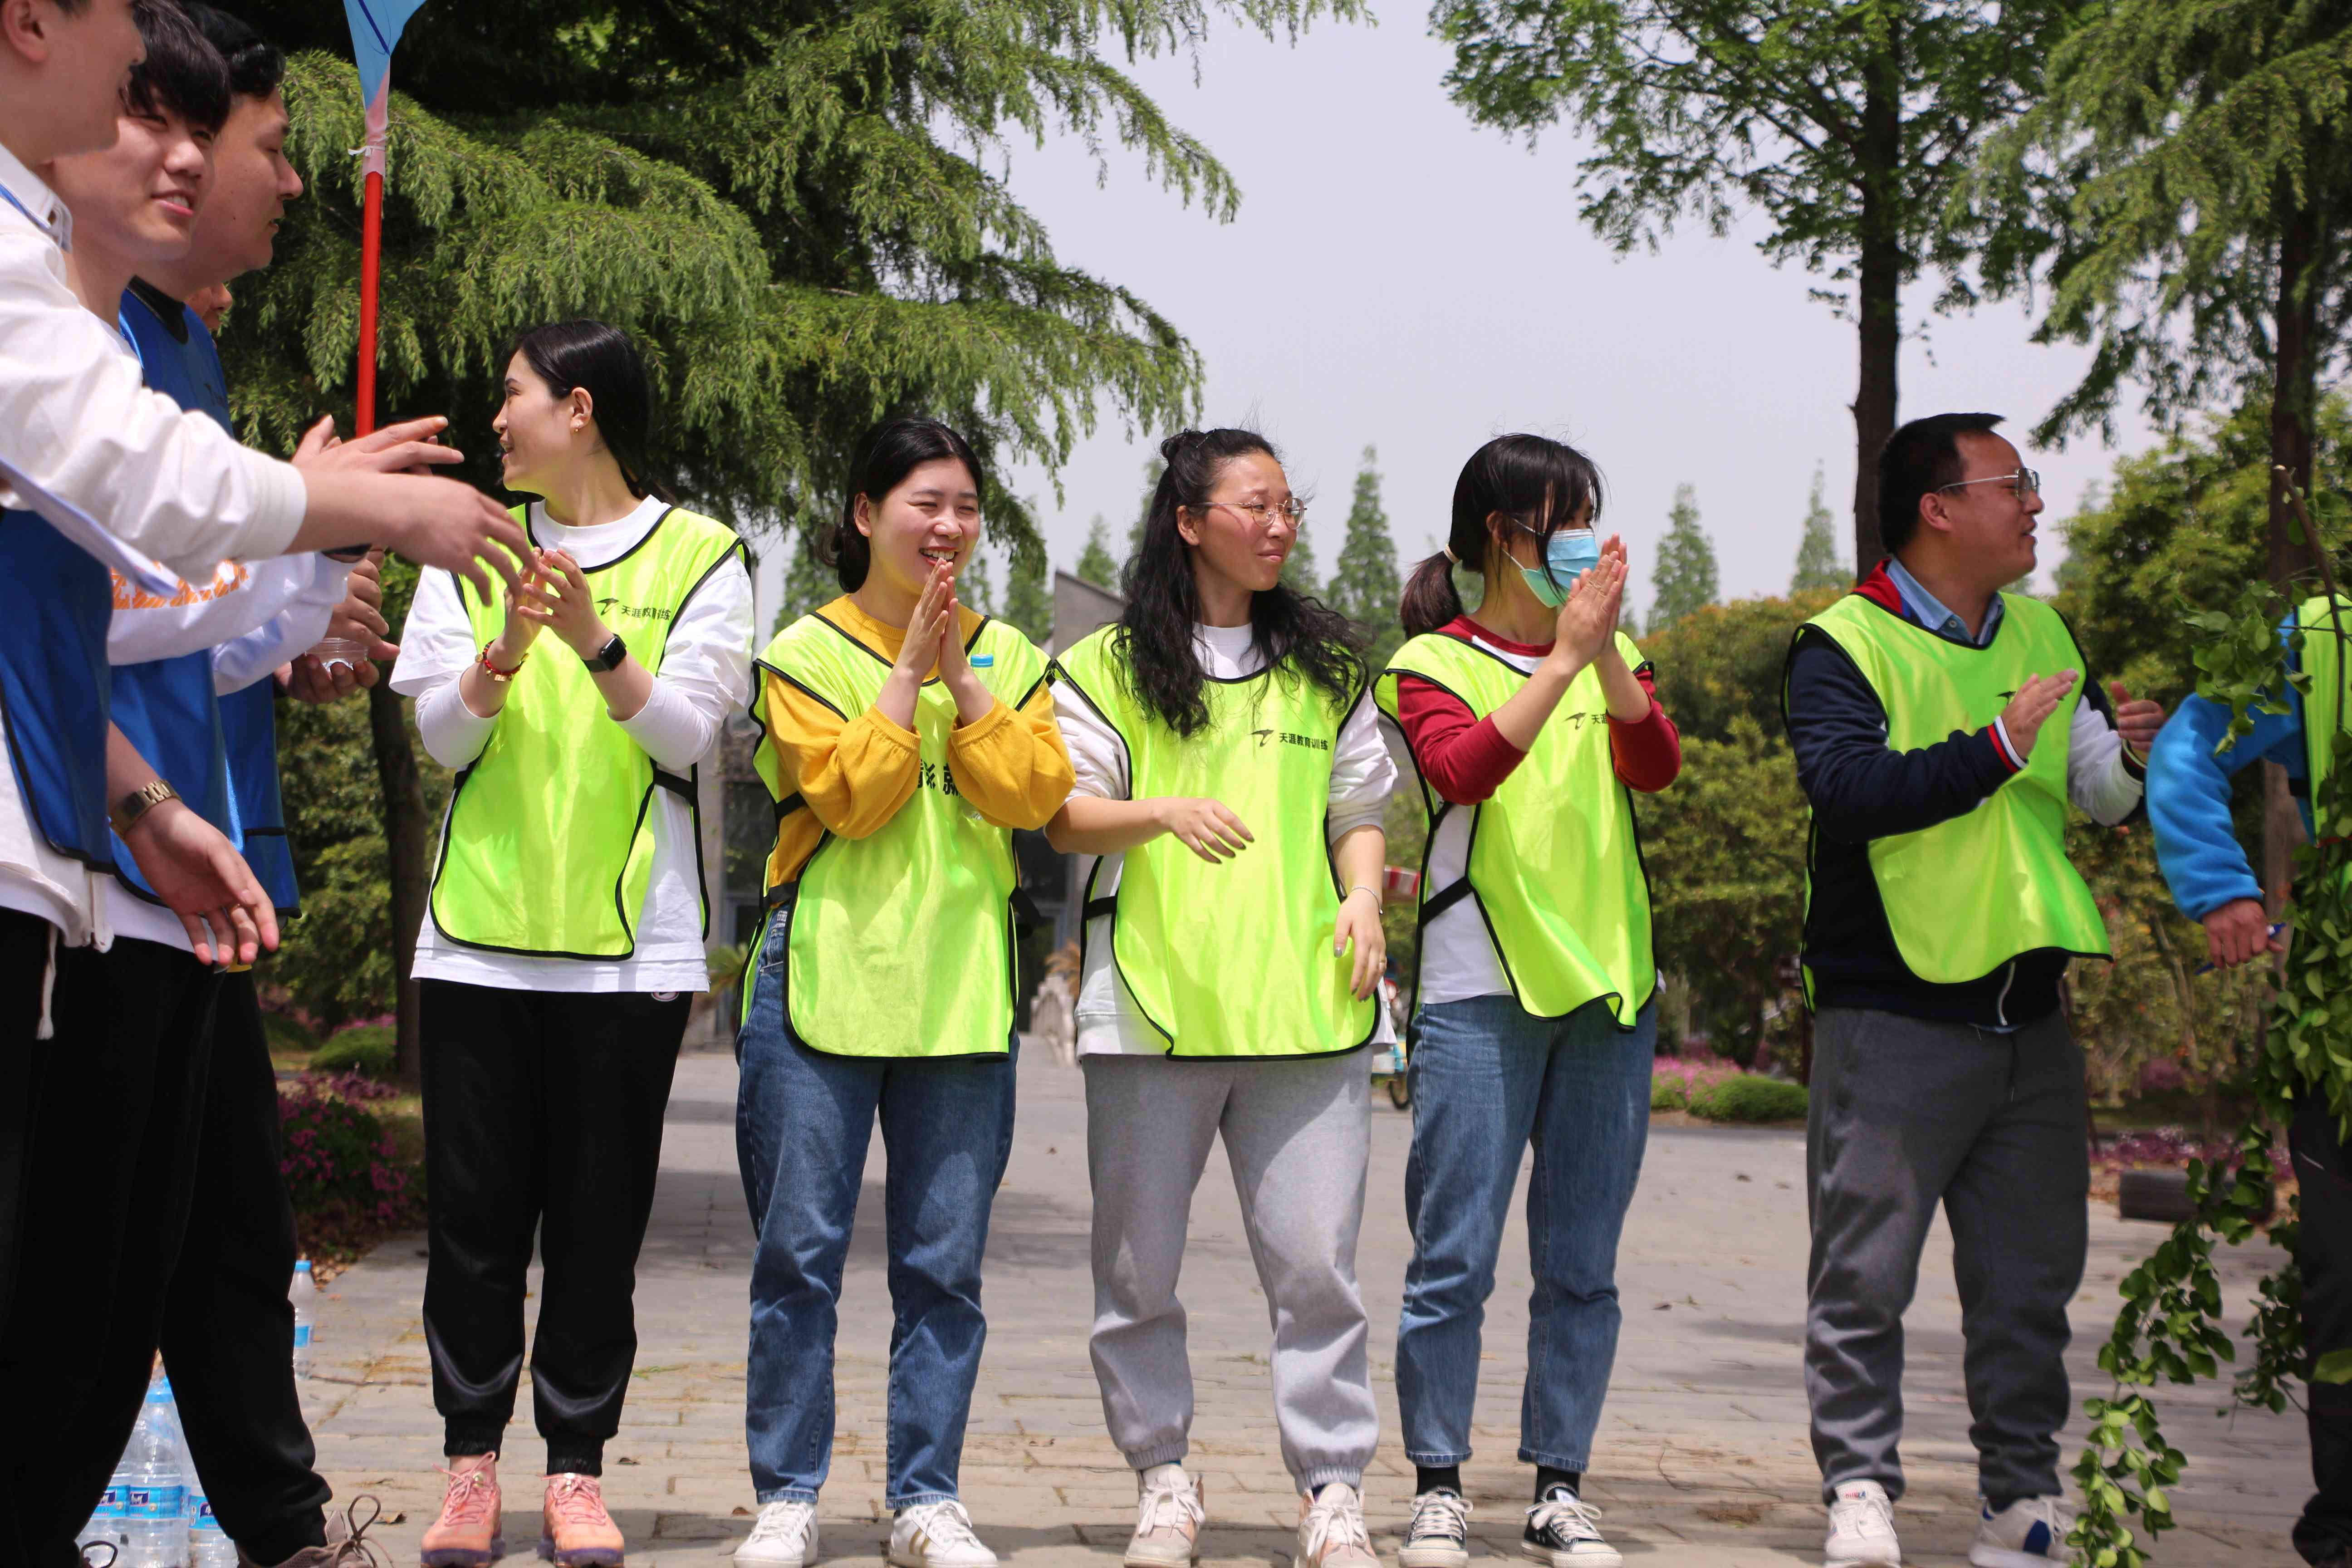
[393,322,753,1566]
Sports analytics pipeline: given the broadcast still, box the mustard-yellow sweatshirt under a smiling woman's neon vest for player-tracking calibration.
[760,595,1070,886]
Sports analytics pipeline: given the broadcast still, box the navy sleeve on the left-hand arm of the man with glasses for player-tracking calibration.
[1788,632,2016,844]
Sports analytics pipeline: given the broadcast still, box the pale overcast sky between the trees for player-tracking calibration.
[762,0,2152,616]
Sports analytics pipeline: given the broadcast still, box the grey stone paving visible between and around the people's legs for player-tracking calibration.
[294,1051,2310,1568]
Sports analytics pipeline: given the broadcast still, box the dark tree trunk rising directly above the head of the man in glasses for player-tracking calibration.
[1853,21,1903,576]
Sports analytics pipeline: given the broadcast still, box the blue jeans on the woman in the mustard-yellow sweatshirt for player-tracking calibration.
[736,921,1014,1509]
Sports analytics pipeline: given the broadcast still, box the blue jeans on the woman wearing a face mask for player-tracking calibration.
[1397,997,1658,1469]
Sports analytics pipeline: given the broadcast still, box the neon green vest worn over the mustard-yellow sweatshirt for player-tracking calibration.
[753,613,1047,1055]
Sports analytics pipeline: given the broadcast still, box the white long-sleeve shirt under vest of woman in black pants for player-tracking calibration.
[393,498,753,992]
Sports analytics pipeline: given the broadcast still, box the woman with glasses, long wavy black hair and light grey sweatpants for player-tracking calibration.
[1047,430,1395,1568]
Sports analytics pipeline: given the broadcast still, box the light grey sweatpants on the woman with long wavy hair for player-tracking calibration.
[1079,1051,1381,1490]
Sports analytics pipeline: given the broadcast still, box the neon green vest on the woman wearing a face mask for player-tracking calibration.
[1373,632,1658,1029]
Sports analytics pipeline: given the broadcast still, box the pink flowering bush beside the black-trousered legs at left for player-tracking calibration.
[278,1072,423,1253]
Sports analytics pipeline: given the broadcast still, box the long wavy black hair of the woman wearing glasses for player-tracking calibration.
[1115,430,1364,736]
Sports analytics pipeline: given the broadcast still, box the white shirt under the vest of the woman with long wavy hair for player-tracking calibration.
[1054,625,1397,1055]
